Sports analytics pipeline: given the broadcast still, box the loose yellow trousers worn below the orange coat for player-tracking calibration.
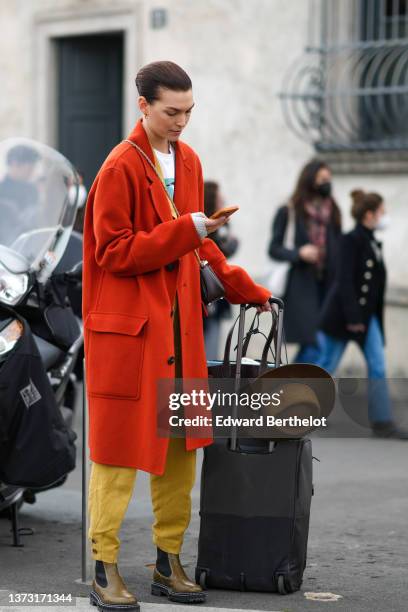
[88,438,196,563]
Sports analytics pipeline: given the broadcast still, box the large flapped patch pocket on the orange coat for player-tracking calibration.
[85,312,148,400]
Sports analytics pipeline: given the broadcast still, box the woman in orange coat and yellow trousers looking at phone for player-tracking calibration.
[83,62,270,610]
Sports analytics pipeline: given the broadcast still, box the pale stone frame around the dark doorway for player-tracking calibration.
[29,2,142,147]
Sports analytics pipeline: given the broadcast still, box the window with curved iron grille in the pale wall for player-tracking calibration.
[281,0,408,160]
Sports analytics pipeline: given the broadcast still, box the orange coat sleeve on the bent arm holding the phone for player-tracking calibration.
[93,167,201,276]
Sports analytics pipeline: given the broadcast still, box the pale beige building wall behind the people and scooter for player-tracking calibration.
[0,0,408,373]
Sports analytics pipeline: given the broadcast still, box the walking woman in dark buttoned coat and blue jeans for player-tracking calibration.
[318,190,408,439]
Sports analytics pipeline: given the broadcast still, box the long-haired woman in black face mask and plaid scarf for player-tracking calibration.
[268,159,341,363]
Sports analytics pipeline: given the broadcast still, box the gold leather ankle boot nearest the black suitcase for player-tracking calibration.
[152,553,206,603]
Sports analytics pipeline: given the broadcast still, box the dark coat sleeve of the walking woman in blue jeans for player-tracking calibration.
[338,234,363,324]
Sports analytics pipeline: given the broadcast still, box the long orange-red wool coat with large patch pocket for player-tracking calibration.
[83,121,269,474]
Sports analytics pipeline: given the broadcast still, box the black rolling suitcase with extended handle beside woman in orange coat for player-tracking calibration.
[196,300,313,594]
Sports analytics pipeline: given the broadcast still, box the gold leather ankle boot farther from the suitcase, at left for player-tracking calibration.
[89,561,140,612]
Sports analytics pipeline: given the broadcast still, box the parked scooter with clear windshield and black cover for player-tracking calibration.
[0,138,83,545]
